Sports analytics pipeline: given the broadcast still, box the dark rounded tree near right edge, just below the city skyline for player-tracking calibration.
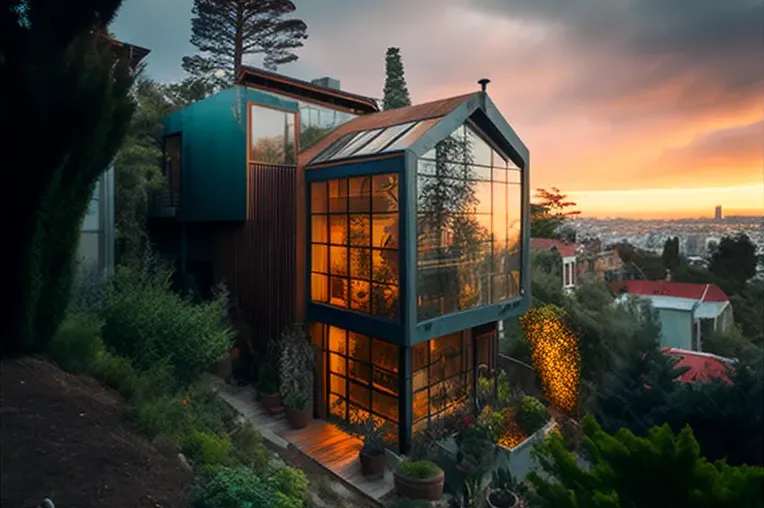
[708,233,759,294]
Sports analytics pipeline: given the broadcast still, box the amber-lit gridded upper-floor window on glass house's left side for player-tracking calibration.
[310,173,399,320]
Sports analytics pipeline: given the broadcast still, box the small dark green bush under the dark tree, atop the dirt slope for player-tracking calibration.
[46,314,103,373]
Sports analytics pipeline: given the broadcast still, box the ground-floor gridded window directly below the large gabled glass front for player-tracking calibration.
[411,331,473,432]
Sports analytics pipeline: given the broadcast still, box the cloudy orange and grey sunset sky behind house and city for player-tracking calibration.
[112,0,764,218]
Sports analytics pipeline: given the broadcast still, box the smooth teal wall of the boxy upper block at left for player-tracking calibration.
[164,86,298,222]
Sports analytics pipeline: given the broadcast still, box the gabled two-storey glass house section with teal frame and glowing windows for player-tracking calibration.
[297,91,530,452]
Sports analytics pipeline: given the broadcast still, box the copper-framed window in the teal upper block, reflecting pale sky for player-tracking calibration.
[249,104,297,165]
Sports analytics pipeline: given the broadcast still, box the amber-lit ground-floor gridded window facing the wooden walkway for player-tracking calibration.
[313,324,399,442]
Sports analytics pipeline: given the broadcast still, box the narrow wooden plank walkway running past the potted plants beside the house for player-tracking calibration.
[207,376,393,502]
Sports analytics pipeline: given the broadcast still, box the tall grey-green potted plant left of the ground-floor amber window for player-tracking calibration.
[279,325,315,429]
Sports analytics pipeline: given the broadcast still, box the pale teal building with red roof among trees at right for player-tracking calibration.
[611,280,733,351]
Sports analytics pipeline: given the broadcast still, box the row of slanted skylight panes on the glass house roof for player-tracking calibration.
[309,117,442,165]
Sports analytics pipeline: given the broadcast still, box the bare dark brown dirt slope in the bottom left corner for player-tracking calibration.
[0,358,192,508]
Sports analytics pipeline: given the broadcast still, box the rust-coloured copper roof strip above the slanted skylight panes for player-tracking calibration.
[298,92,480,166]
